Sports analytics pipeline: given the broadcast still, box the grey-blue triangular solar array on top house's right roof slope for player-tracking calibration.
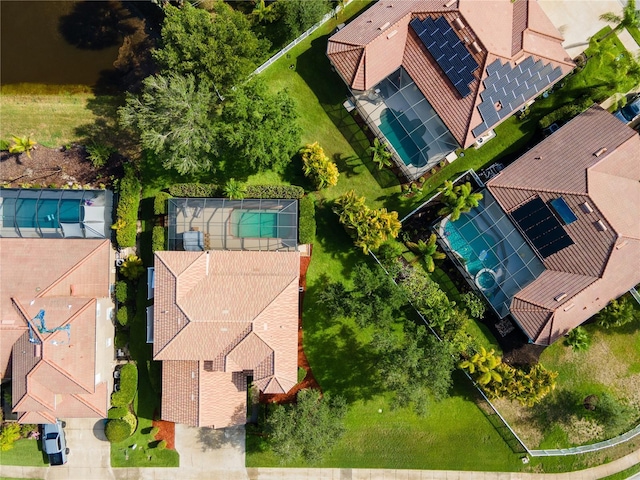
[472,56,562,137]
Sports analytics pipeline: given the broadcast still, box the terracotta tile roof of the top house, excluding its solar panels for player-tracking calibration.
[327,0,574,148]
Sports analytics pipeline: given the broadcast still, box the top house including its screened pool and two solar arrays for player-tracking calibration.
[327,0,574,178]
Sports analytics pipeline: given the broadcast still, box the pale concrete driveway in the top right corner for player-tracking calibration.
[538,0,638,58]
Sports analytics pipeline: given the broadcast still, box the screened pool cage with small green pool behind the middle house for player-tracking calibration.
[167,198,298,251]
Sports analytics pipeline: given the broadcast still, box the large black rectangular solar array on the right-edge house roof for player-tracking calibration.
[511,197,573,258]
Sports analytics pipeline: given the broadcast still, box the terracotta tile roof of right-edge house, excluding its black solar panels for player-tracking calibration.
[487,105,640,344]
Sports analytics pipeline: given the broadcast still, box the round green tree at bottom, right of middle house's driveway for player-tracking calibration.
[267,389,347,463]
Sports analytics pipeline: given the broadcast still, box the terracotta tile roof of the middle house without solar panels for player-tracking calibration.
[154,251,300,426]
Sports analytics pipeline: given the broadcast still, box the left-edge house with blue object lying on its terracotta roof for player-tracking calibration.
[0,238,115,423]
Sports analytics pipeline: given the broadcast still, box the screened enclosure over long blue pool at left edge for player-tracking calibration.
[0,188,113,238]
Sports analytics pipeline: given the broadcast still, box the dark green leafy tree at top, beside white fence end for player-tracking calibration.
[153,0,266,96]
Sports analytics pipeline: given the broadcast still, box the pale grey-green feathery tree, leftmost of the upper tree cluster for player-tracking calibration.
[118,74,216,174]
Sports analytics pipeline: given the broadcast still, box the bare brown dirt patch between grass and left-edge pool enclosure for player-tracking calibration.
[0,145,121,188]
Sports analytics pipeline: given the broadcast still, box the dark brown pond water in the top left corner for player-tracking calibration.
[0,0,123,85]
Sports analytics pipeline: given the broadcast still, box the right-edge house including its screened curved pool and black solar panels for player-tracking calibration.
[439,106,640,345]
